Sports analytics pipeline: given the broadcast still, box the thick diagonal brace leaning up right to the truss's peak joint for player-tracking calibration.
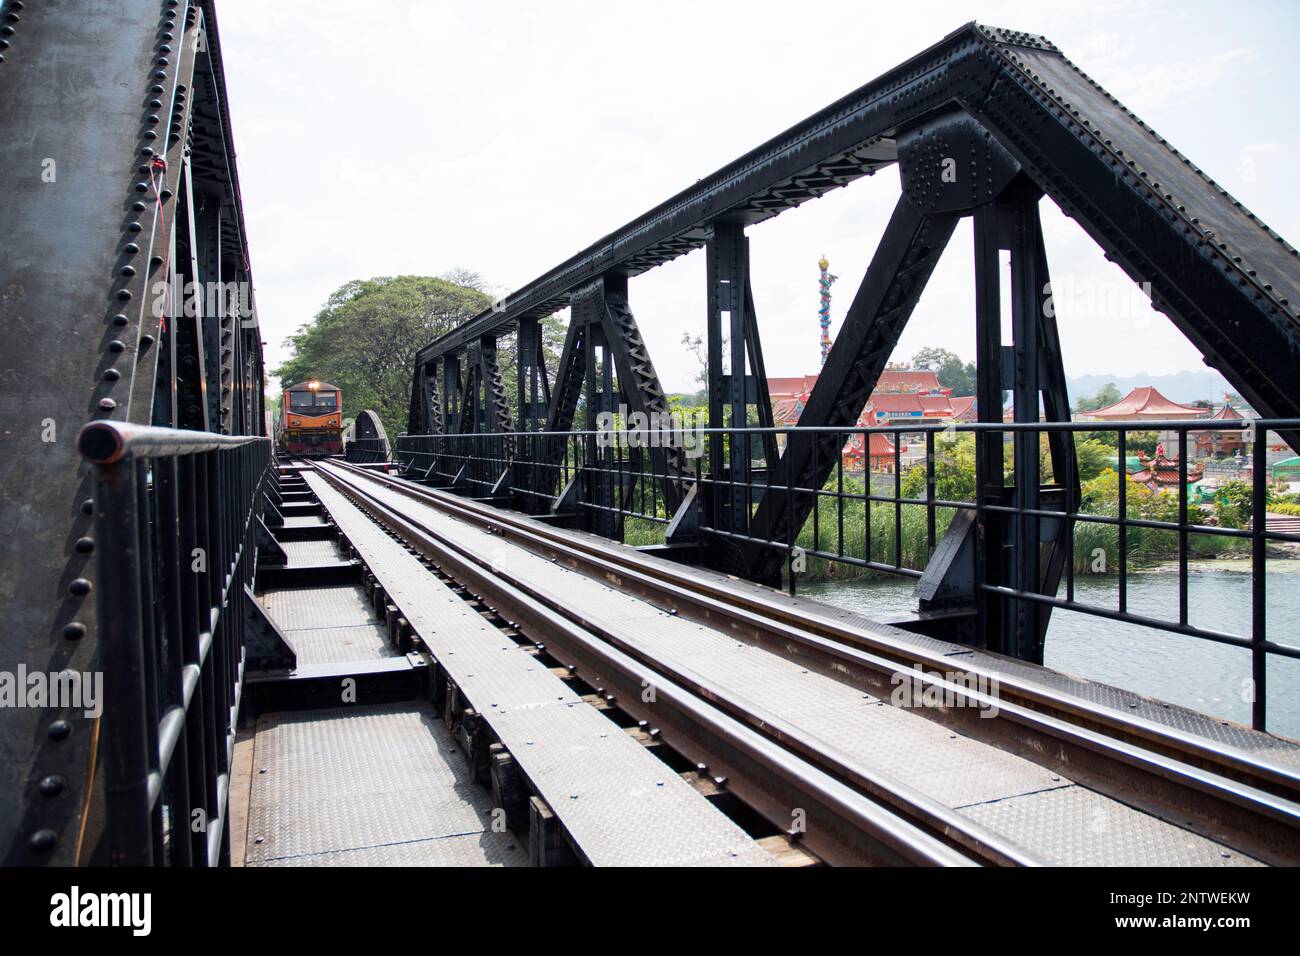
[740,196,959,583]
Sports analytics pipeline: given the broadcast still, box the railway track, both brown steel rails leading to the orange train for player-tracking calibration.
[306,462,1300,865]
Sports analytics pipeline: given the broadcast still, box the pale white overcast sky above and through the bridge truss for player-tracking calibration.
[217,0,1300,392]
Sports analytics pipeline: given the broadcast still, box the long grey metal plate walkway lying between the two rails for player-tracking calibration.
[340,470,1255,866]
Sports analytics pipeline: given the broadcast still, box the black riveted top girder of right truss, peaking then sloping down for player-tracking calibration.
[410,23,1300,460]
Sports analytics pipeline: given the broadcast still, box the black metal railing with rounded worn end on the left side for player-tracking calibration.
[78,421,274,865]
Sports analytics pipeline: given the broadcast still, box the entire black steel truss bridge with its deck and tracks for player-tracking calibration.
[0,0,1300,865]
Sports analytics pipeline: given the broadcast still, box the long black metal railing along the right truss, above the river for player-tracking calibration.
[395,419,1300,728]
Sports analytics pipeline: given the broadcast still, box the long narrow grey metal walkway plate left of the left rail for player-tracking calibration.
[306,475,776,866]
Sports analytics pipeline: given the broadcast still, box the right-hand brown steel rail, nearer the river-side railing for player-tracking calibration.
[322,464,1300,862]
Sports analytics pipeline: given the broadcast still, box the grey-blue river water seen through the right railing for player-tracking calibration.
[800,561,1300,740]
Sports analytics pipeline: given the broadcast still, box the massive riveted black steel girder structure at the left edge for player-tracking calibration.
[0,0,264,865]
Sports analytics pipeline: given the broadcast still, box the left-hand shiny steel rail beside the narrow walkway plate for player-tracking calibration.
[304,462,1044,866]
